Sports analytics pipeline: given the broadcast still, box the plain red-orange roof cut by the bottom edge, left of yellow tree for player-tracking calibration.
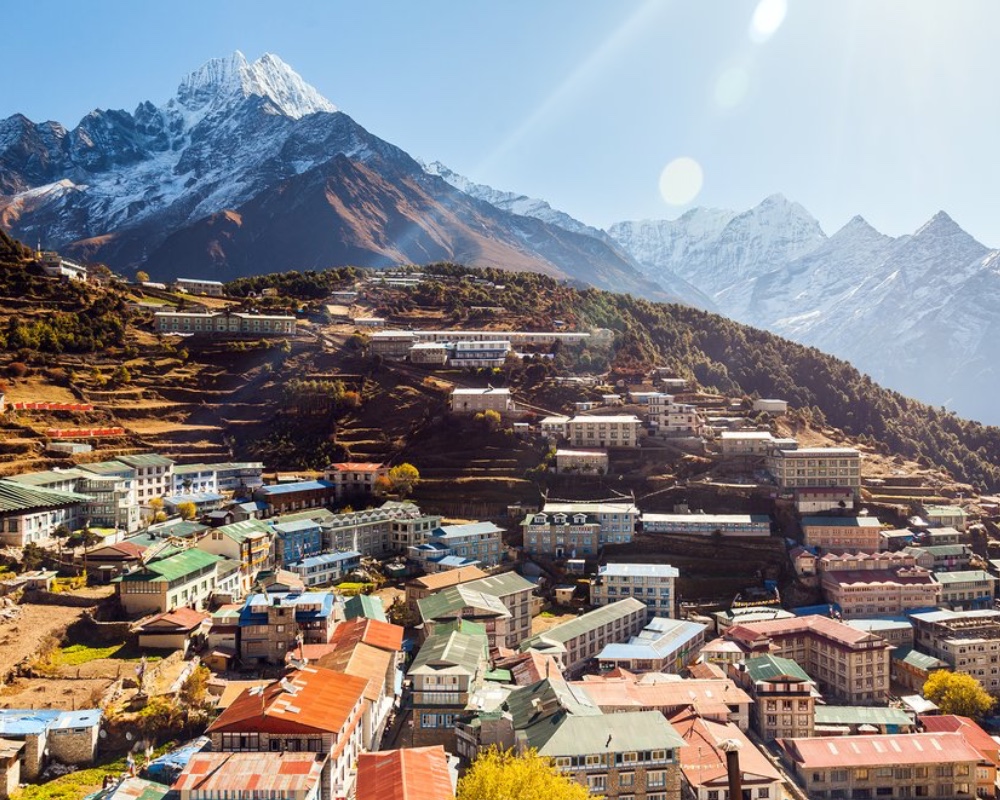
[355,745,455,800]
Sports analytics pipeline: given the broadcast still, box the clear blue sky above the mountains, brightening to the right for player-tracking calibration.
[0,0,1000,246]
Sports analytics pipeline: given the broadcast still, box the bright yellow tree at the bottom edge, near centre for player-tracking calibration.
[456,748,590,800]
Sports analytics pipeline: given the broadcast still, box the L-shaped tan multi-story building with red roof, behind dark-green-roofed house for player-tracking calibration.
[726,614,892,705]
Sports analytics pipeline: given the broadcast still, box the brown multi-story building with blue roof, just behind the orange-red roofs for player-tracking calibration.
[239,592,343,664]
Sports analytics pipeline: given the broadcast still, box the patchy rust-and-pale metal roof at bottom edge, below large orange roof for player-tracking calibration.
[171,752,323,797]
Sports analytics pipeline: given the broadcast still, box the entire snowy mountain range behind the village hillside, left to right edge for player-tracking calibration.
[0,53,1000,424]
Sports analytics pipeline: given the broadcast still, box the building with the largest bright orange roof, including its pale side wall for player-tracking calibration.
[206,666,368,800]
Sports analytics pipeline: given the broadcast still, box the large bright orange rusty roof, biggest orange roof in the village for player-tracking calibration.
[207,666,368,734]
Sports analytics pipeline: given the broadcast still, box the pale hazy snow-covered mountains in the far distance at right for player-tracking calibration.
[608,195,1000,424]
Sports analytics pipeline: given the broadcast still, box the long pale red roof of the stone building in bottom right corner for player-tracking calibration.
[779,733,980,769]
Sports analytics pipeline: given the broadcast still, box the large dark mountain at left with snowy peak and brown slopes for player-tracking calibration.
[0,52,677,299]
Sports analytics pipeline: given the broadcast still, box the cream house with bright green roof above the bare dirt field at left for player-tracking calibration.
[115,547,222,616]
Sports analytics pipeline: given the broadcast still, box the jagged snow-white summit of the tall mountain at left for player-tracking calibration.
[177,50,337,119]
